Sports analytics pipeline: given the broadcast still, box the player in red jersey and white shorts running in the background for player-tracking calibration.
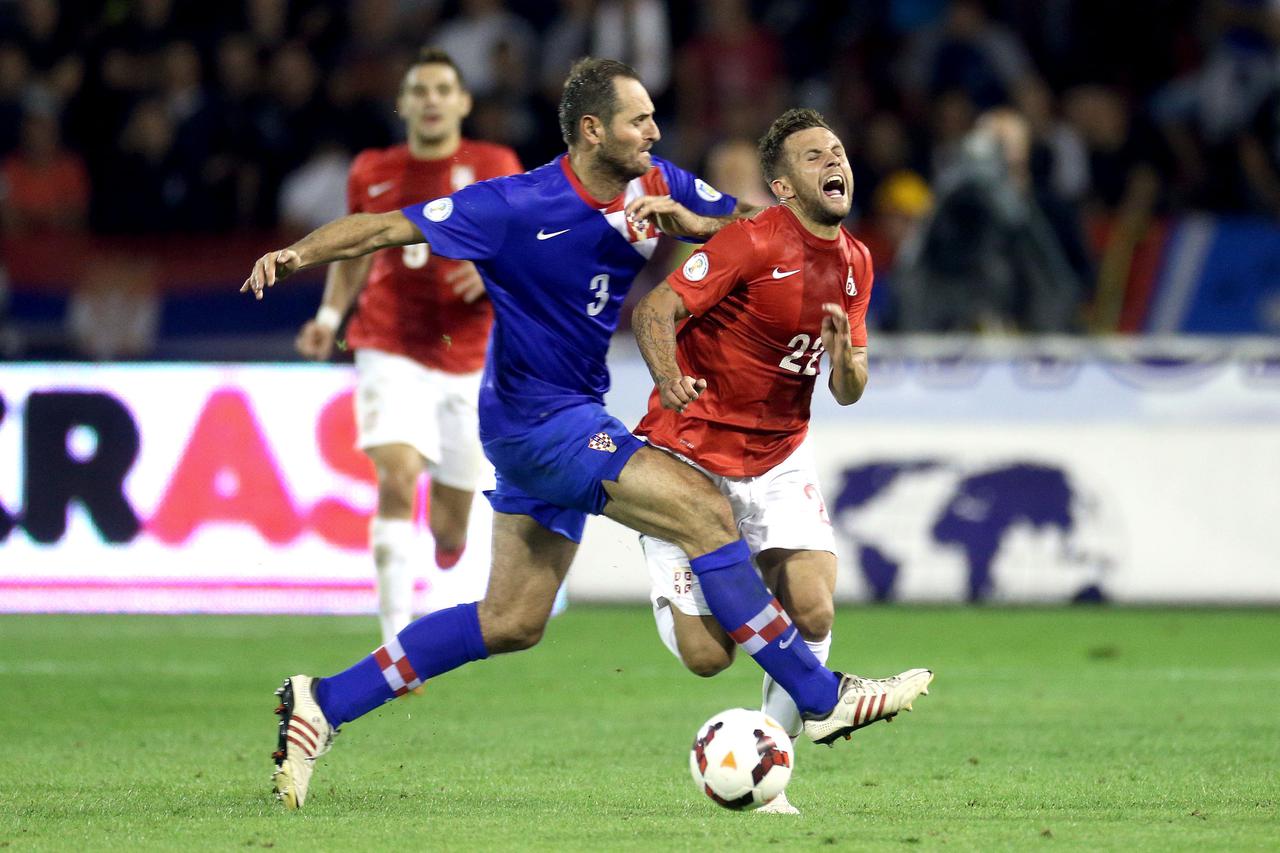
[297,49,522,640]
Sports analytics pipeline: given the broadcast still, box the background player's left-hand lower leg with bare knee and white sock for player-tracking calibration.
[365,443,426,643]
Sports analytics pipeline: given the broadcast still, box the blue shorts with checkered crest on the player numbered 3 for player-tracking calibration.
[481,403,644,542]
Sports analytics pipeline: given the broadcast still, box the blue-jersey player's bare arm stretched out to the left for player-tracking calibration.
[241,210,422,298]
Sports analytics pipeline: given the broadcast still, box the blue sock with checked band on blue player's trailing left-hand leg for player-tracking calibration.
[315,602,486,729]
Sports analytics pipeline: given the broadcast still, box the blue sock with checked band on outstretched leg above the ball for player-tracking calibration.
[689,539,840,715]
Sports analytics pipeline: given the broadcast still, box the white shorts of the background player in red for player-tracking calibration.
[356,350,485,492]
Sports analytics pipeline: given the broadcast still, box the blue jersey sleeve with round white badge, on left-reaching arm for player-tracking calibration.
[403,179,511,260]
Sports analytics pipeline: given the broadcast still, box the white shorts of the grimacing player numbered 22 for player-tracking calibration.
[640,438,836,616]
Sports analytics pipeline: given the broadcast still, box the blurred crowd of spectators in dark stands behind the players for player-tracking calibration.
[0,0,1280,332]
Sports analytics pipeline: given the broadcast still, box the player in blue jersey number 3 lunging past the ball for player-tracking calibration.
[241,59,932,808]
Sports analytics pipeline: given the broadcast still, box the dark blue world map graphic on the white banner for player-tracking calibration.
[832,459,1123,601]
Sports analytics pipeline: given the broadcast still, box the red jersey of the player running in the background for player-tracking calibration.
[347,140,524,373]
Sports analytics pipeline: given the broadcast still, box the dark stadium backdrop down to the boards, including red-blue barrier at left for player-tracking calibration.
[0,0,1280,350]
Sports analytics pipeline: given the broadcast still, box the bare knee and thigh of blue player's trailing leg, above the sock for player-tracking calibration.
[477,512,577,654]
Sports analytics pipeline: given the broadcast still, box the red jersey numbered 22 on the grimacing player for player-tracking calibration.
[636,205,873,476]
